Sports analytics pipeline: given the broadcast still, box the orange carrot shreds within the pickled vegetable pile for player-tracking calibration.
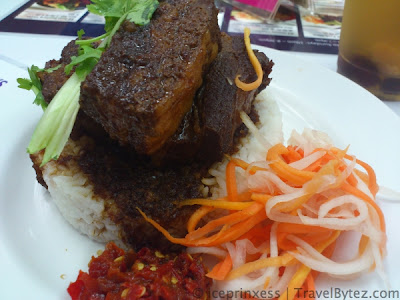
[139,144,386,300]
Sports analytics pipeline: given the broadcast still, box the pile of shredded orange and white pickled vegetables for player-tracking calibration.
[141,130,386,299]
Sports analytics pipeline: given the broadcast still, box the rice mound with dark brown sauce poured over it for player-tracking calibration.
[31,90,280,250]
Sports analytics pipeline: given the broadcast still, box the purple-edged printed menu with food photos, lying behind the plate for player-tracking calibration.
[0,0,342,54]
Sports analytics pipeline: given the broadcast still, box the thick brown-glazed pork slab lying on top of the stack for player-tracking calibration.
[80,0,220,154]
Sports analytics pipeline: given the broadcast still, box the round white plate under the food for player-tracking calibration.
[0,44,400,300]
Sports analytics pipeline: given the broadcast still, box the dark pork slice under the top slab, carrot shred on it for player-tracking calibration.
[153,33,273,165]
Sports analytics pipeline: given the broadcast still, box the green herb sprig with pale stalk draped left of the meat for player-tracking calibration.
[17,0,159,166]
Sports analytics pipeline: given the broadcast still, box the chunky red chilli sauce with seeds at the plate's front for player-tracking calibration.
[68,243,212,300]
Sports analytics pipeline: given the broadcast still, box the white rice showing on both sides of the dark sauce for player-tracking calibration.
[31,91,283,245]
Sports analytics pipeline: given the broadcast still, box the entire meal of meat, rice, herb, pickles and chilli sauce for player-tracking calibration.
[19,0,386,299]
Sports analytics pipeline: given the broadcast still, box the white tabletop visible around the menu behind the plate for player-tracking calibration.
[0,0,400,116]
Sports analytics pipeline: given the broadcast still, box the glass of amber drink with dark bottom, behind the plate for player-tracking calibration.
[338,0,400,101]
